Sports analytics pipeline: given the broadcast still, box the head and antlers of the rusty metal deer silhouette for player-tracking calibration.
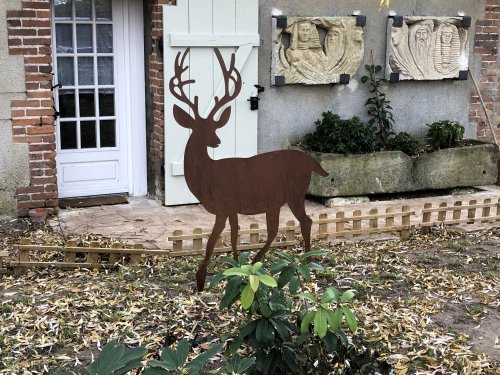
[169,48,242,147]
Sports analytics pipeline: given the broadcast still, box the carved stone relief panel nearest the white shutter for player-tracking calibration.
[271,16,364,85]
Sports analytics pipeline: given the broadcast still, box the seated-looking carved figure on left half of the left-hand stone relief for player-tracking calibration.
[286,21,327,83]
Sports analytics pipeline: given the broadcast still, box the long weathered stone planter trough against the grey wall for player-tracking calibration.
[298,141,499,198]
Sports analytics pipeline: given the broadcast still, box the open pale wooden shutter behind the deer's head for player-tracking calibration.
[163,0,259,205]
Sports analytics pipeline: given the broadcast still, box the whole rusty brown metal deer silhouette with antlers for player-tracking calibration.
[169,48,328,291]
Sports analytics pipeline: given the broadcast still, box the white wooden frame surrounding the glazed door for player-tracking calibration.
[51,0,147,198]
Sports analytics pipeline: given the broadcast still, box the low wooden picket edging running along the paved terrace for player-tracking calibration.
[4,199,500,274]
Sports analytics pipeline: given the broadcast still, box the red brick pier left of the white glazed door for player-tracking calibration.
[7,0,57,216]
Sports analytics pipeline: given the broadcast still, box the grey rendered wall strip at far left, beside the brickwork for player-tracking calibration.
[0,0,30,218]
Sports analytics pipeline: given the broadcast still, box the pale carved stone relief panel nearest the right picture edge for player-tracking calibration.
[386,16,469,80]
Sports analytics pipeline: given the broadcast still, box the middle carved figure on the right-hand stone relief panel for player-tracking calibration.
[409,20,435,77]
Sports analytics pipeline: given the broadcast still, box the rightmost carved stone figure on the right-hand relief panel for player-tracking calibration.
[434,23,460,76]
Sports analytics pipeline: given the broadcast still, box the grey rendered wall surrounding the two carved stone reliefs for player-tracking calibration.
[258,0,485,152]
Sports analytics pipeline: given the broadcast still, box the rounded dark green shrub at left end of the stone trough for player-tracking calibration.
[302,111,375,155]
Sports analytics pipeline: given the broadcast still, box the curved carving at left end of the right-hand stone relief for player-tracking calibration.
[389,23,423,79]
